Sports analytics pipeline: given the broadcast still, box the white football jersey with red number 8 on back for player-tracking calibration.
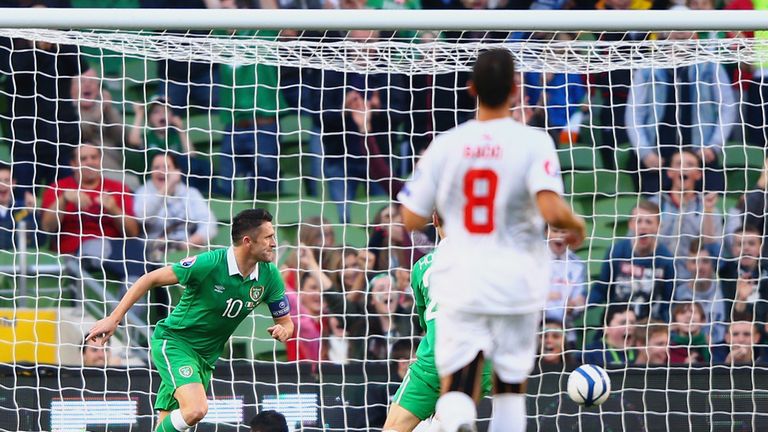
[398,118,563,314]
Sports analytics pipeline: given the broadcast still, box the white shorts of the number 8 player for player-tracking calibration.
[435,308,541,384]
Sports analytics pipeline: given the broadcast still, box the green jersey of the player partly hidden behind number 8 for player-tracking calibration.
[411,252,437,374]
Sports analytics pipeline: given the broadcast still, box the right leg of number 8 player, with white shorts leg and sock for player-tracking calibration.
[489,313,541,432]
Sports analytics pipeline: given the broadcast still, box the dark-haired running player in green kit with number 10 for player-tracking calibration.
[87,209,293,432]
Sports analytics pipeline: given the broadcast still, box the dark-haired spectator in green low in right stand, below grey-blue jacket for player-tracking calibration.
[669,302,710,364]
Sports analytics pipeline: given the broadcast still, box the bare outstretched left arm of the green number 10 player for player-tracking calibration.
[86,266,179,344]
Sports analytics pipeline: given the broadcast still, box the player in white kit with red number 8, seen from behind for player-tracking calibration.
[398,49,584,432]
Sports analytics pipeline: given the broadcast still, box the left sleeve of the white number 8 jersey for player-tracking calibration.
[397,140,440,217]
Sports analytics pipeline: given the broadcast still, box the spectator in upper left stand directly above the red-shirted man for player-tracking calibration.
[71,69,140,190]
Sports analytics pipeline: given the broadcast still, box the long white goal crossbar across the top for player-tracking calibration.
[0,8,768,31]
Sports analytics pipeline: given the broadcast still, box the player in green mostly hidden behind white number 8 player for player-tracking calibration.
[383,213,493,432]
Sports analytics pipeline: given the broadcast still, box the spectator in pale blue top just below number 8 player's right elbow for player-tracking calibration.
[544,227,587,334]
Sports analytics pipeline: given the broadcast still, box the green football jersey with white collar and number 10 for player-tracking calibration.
[152,248,289,366]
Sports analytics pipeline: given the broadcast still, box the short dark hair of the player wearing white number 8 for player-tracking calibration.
[472,48,515,108]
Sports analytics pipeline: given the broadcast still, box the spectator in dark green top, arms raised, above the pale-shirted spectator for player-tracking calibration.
[128,96,210,192]
